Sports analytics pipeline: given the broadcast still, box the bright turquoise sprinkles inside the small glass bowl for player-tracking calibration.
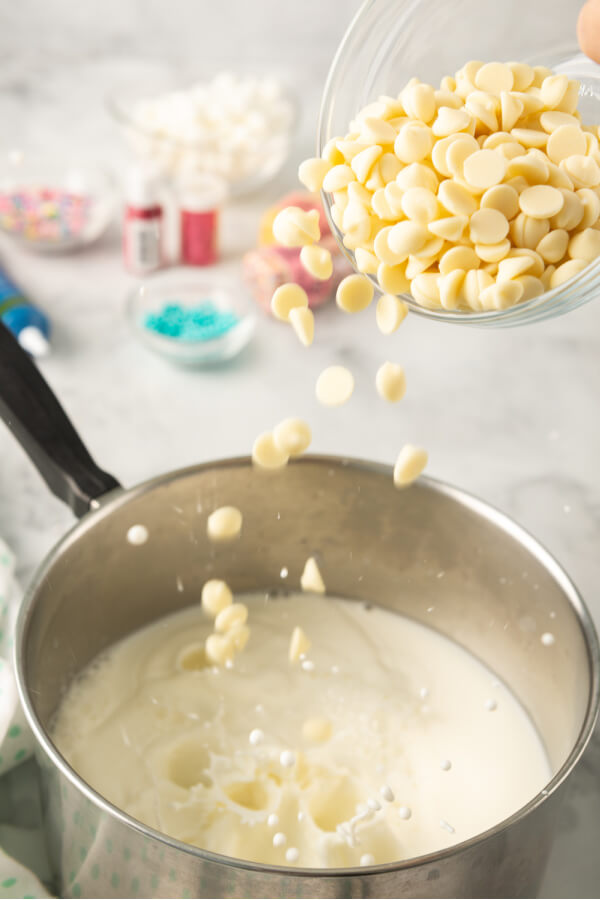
[144,300,239,342]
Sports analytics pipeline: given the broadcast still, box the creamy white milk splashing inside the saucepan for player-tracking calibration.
[54,594,551,867]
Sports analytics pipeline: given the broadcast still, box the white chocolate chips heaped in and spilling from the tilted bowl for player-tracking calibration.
[274,61,600,314]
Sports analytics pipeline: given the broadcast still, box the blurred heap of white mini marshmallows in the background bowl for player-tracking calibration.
[108,72,297,196]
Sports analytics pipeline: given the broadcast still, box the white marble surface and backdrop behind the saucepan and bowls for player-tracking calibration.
[0,0,600,897]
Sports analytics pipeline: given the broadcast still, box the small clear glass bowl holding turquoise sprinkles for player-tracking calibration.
[127,275,256,366]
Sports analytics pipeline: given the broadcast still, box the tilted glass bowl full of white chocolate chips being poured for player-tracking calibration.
[316,0,600,325]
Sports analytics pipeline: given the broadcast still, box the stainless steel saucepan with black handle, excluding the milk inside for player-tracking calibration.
[0,326,599,897]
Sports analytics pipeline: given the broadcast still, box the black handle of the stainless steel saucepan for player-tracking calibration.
[0,323,120,516]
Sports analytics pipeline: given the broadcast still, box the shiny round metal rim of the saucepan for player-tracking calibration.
[14,454,600,879]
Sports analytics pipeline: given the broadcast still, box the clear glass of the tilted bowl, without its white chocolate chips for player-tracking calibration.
[317,0,600,326]
